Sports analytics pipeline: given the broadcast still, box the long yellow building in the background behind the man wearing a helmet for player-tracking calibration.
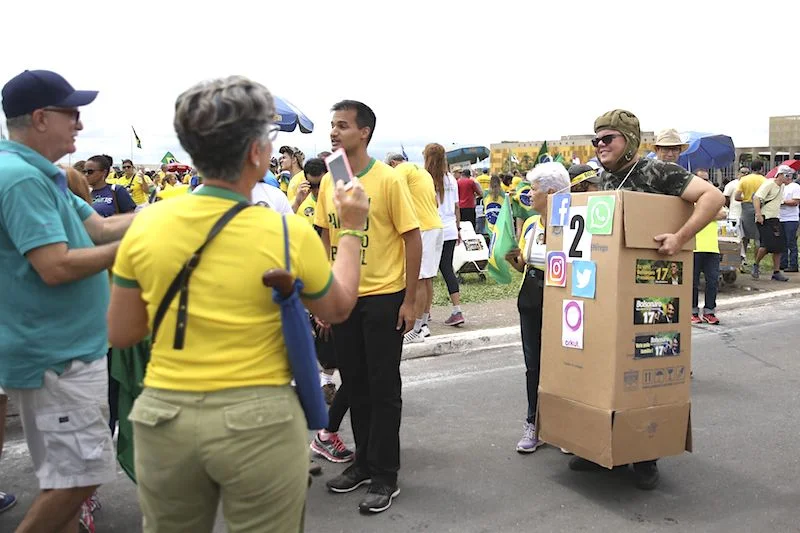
[489,131,656,173]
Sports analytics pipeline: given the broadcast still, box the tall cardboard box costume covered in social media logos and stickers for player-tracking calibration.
[537,191,694,467]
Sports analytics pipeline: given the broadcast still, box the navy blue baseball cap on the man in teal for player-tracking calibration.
[3,70,97,118]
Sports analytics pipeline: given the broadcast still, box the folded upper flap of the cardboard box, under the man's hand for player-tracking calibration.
[622,191,694,251]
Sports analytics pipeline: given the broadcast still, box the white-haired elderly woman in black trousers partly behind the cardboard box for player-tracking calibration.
[506,163,570,453]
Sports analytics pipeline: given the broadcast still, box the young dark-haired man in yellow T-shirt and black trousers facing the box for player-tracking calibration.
[314,100,422,514]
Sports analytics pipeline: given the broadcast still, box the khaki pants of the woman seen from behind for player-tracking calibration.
[129,386,308,533]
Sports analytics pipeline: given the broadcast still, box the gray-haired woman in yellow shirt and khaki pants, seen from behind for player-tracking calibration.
[108,77,368,533]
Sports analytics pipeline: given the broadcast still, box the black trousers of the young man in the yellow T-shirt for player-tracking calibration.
[333,290,405,485]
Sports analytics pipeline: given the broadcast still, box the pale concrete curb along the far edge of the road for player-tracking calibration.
[403,288,800,359]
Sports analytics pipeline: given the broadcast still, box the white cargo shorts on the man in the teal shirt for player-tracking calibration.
[6,356,117,490]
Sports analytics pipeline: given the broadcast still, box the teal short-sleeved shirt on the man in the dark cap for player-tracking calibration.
[0,141,109,389]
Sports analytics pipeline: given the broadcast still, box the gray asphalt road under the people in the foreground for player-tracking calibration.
[0,302,800,533]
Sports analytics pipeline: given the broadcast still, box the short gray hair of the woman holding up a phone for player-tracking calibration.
[174,76,275,183]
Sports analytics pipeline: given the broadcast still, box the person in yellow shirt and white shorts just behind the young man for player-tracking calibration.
[386,153,444,343]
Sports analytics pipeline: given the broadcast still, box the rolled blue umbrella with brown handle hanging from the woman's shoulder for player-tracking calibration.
[263,216,328,429]
